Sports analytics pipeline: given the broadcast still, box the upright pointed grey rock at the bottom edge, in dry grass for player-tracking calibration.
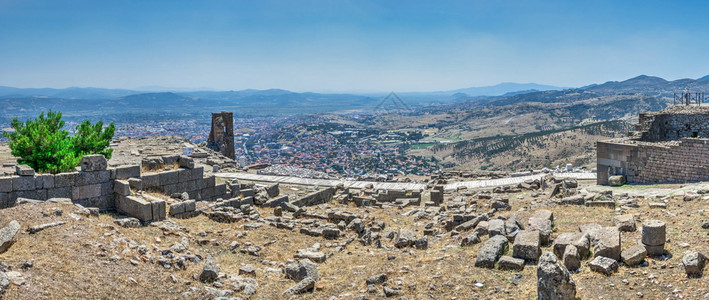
[537,252,576,300]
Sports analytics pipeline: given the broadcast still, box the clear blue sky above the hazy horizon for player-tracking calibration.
[0,0,709,92]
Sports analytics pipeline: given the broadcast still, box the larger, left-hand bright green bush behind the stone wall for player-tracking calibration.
[3,110,81,173]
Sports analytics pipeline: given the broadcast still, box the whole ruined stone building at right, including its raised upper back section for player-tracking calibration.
[596,105,709,184]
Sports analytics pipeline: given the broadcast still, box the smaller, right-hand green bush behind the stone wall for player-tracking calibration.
[72,120,116,159]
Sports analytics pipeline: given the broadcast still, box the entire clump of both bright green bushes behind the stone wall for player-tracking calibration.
[3,110,115,174]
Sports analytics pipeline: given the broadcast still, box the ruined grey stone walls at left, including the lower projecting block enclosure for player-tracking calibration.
[0,155,232,222]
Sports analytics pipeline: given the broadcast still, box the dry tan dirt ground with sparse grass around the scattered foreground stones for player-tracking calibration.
[0,179,709,299]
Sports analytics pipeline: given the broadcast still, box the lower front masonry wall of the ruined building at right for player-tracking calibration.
[597,138,709,184]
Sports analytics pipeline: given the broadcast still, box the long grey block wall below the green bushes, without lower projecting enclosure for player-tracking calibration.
[0,155,231,210]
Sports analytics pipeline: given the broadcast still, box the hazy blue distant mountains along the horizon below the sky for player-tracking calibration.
[0,75,709,118]
